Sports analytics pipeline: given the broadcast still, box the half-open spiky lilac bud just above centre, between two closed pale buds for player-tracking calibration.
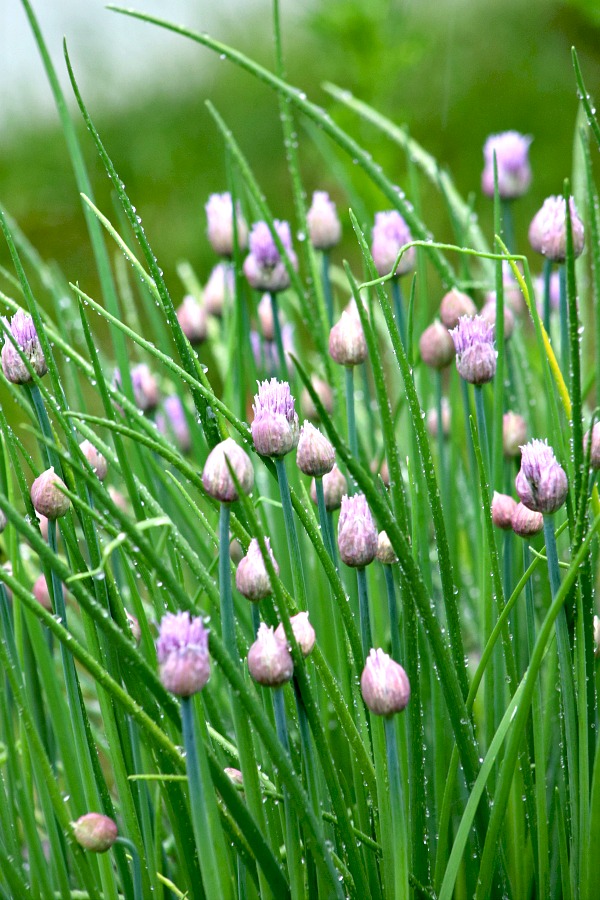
[251,378,299,456]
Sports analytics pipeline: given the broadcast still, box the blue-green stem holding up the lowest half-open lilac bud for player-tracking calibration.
[181,697,232,898]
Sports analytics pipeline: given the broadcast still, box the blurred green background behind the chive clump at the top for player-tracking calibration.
[0,0,600,308]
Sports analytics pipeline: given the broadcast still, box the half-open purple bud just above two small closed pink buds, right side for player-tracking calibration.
[515,440,569,515]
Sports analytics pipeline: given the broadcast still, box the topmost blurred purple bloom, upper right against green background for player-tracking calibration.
[481,131,533,200]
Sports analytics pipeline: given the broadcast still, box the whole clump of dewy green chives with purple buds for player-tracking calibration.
[0,0,600,900]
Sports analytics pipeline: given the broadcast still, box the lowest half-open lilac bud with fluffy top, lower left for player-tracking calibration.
[156,612,210,697]
